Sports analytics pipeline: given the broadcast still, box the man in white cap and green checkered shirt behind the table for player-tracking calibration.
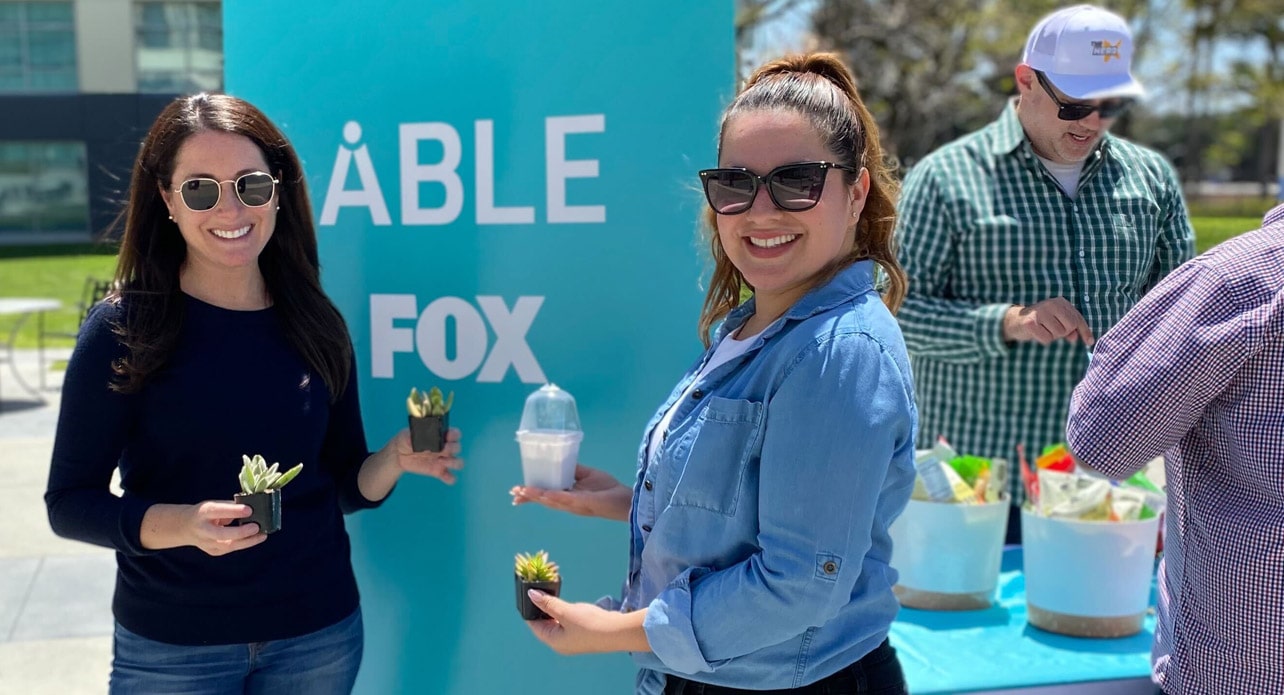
[898,5,1194,540]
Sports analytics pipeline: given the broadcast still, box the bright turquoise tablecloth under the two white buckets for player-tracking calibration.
[890,546,1154,695]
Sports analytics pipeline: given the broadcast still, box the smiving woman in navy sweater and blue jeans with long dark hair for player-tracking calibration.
[45,94,461,694]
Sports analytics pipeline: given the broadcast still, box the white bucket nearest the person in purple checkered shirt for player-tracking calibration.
[1021,510,1159,637]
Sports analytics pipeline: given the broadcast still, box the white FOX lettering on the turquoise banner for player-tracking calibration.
[370,294,546,384]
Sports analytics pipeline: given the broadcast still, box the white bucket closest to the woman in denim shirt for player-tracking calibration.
[891,497,1009,610]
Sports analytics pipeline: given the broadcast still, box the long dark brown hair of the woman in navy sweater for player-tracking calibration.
[112,94,352,401]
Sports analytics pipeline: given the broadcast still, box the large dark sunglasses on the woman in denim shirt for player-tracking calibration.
[700,162,859,215]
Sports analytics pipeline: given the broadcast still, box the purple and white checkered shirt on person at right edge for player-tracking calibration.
[1067,206,1284,695]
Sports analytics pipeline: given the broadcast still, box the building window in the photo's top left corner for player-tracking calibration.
[0,1,78,94]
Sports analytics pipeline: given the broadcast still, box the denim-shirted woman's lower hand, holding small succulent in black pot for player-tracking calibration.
[526,588,651,654]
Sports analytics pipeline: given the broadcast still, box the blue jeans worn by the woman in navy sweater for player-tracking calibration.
[110,608,365,695]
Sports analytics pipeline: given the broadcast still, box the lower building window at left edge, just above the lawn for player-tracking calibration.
[0,140,89,232]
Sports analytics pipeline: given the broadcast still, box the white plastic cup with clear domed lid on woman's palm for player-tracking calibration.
[517,384,584,489]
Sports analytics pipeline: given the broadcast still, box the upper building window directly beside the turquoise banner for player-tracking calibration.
[134,1,223,94]
